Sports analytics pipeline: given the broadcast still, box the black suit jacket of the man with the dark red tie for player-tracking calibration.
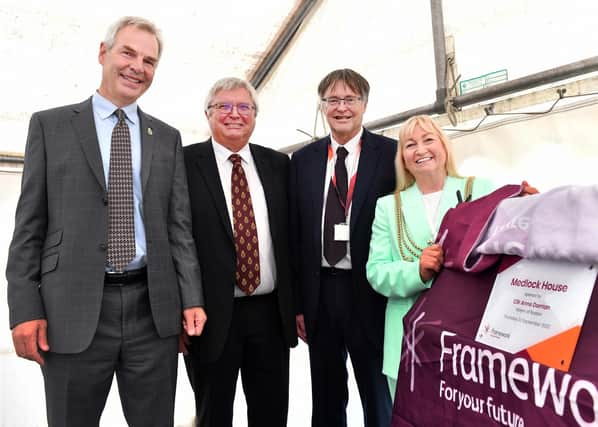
[184,139,297,362]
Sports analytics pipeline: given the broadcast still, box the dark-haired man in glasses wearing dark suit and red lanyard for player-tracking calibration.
[290,69,397,427]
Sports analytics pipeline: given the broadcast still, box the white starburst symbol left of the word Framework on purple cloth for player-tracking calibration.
[401,295,442,392]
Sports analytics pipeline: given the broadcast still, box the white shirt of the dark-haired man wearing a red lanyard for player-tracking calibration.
[320,128,363,270]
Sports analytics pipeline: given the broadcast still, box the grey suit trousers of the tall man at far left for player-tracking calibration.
[42,281,178,427]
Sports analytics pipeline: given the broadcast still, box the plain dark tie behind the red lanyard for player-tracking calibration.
[324,147,348,266]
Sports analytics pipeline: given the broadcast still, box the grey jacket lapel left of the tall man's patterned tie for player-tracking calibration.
[72,98,106,191]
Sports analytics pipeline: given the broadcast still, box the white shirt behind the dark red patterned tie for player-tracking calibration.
[212,138,276,297]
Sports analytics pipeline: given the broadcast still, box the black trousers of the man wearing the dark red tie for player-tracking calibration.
[185,293,289,427]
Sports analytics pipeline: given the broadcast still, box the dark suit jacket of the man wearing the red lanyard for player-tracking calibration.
[290,129,397,350]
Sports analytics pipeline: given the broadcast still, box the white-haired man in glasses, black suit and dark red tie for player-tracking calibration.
[184,78,297,427]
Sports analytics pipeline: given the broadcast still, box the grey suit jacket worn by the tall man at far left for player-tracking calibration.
[6,99,203,353]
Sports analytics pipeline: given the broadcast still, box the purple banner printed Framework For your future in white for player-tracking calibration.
[392,263,598,427]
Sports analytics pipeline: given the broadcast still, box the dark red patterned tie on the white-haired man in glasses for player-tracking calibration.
[229,154,260,295]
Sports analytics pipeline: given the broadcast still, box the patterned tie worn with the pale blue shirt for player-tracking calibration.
[106,109,135,271]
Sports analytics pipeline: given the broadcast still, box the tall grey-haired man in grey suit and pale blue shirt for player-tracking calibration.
[6,17,206,427]
